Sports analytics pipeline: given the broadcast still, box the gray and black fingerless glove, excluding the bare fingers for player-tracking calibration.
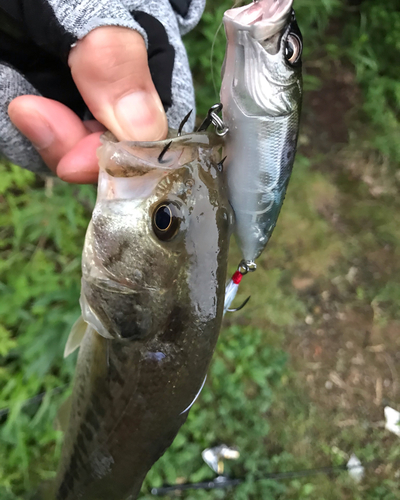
[0,0,205,173]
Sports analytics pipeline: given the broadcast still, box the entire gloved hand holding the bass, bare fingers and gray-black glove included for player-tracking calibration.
[0,0,205,183]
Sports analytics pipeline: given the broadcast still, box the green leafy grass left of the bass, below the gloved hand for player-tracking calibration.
[0,169,95,498]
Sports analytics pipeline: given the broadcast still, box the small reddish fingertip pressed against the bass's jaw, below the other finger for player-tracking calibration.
[57,132,103,184]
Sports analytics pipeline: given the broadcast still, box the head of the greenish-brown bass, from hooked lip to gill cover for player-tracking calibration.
[81,134,231,340]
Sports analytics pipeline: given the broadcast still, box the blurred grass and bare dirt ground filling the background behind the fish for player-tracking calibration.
[0,0,400,500]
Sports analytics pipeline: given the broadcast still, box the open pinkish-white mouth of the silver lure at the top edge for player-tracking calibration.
[224,0,293,39]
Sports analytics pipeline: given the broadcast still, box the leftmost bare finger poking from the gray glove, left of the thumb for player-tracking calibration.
[8,95,90,172]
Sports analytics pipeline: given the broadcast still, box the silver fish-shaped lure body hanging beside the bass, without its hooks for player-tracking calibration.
[221,0,302,262]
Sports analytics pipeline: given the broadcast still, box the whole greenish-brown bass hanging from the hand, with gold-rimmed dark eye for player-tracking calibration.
[55,133,232,500]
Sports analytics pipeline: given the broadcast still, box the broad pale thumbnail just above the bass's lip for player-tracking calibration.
[115,92,168,141]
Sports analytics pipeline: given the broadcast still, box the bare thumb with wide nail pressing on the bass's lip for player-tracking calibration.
[68,26,168,141]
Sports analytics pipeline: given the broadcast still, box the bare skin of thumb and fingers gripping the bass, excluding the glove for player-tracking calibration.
[8,26,168,183]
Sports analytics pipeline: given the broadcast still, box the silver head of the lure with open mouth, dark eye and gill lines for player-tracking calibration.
[221,0,303,117]
